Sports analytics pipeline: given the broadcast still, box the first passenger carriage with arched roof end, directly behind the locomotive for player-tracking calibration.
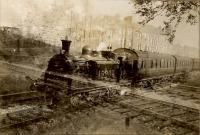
[114,48,175,79]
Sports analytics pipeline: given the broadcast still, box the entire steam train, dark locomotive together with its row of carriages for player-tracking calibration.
[44,40,200,83]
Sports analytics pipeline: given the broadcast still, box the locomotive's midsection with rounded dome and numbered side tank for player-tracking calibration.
[80,46,118,79]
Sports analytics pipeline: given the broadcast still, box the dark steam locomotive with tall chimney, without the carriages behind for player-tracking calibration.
[44,40,119,81]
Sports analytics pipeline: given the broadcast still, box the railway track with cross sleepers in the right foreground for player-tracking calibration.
[96,95,200,135]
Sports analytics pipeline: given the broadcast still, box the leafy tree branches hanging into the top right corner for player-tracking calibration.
[130,0,200,43]
